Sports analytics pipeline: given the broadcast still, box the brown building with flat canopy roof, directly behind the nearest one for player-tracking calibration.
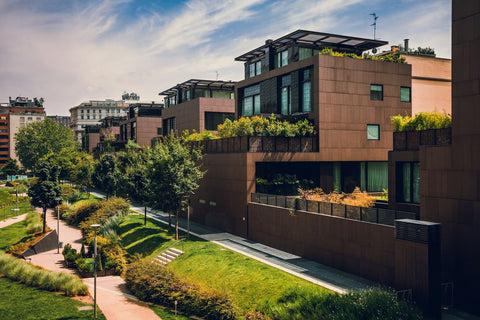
[159,79,235,135]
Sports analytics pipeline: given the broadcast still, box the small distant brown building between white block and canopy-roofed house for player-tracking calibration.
[120,103,163,147]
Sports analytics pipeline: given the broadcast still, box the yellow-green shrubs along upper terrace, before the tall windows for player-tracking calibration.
[184,115,316,141]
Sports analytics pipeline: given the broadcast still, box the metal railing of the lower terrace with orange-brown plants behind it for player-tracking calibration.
[251,193,418,226]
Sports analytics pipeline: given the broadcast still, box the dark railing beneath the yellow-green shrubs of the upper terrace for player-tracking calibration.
[194,136,318,153]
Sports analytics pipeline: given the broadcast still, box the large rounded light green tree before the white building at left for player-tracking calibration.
[15,118,75,170]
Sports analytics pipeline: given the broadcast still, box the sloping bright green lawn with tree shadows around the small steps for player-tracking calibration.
[119,215,331,314]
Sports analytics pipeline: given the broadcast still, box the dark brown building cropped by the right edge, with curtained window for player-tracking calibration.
[389,0,480,314]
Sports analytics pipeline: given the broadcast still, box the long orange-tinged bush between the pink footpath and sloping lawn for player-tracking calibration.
[125,261,235,319]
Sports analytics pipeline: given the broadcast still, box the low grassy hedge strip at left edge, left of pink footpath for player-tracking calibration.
[0,252,88,296]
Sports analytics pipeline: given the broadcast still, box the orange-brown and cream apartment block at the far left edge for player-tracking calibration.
[0,97,45,166]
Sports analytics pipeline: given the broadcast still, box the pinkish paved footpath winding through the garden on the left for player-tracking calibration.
[0,209,160,320]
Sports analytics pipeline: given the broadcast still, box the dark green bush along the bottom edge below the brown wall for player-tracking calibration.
[262,288,422,320]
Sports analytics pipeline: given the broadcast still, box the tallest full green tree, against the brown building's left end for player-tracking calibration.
[147,135,205,240]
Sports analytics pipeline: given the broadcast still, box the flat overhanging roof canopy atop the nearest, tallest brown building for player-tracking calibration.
[235,30,388,61]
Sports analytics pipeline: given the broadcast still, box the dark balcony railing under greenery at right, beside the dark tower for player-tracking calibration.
[393,128,452,151]
